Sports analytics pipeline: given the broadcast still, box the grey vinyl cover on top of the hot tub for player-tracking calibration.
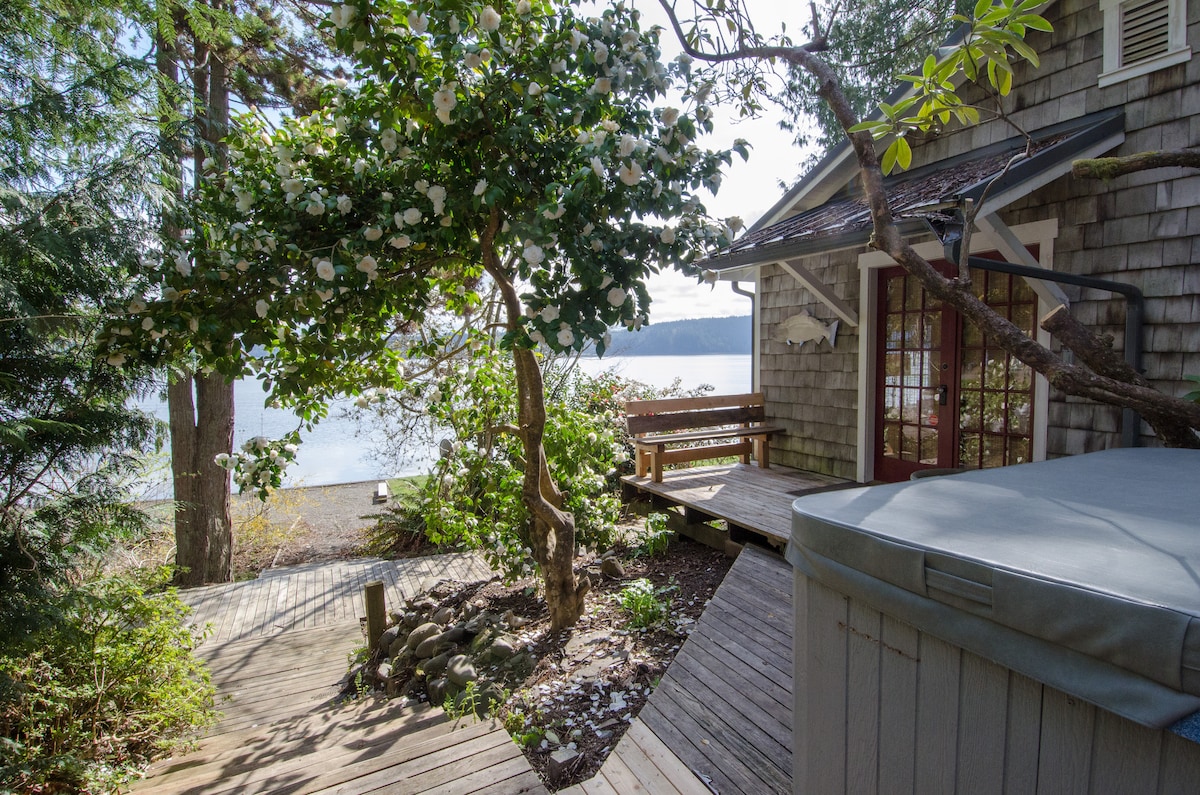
[787,449,1200,727]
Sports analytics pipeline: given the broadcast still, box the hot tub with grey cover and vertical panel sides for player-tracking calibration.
[787,449,1200,795]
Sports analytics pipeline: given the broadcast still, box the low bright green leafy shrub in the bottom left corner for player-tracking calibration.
[0,570,216,793]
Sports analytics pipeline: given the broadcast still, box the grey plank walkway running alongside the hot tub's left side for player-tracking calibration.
[564,546,793,795]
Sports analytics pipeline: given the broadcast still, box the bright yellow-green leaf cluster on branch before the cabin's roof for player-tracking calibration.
[850,0,1052,174]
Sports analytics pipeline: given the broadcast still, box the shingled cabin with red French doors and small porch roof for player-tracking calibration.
[703,0,1200,483]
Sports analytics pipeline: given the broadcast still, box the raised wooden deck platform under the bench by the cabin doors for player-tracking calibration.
[622,464,856,549]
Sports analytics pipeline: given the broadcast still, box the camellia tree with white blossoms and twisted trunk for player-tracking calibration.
[110,0,746,628]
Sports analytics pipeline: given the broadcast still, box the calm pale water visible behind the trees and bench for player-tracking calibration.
[133,354,751,496]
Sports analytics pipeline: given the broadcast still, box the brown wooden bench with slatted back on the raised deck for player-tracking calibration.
[625,393,784,483]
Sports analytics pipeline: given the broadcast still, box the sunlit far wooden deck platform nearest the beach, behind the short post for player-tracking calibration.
[180,554,493,644]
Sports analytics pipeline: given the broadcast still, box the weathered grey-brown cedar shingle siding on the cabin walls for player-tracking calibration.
[760,0,1200,478]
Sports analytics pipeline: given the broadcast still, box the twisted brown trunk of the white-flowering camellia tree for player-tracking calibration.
[480,211,592,632]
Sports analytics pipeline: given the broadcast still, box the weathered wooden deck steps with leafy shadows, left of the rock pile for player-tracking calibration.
[134,624,546,795]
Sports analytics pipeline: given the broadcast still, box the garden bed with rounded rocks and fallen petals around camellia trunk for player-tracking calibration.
[352,538,732,789]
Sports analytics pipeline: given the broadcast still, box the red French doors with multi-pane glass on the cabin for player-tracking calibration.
[875,263,1037,480]
